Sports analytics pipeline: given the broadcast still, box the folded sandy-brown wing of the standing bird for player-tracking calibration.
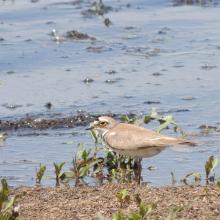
[105,123,187,150]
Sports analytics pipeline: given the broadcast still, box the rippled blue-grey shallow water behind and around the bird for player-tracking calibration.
[0,0,220,186]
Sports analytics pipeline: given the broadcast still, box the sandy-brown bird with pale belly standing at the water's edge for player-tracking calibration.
[90,116,194,183]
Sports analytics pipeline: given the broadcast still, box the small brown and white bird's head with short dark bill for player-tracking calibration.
[90,116,117,134]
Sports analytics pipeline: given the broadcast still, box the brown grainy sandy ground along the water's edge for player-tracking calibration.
[14,184,220,220]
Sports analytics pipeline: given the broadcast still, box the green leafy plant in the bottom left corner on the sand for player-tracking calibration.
[0,179,18,220]
